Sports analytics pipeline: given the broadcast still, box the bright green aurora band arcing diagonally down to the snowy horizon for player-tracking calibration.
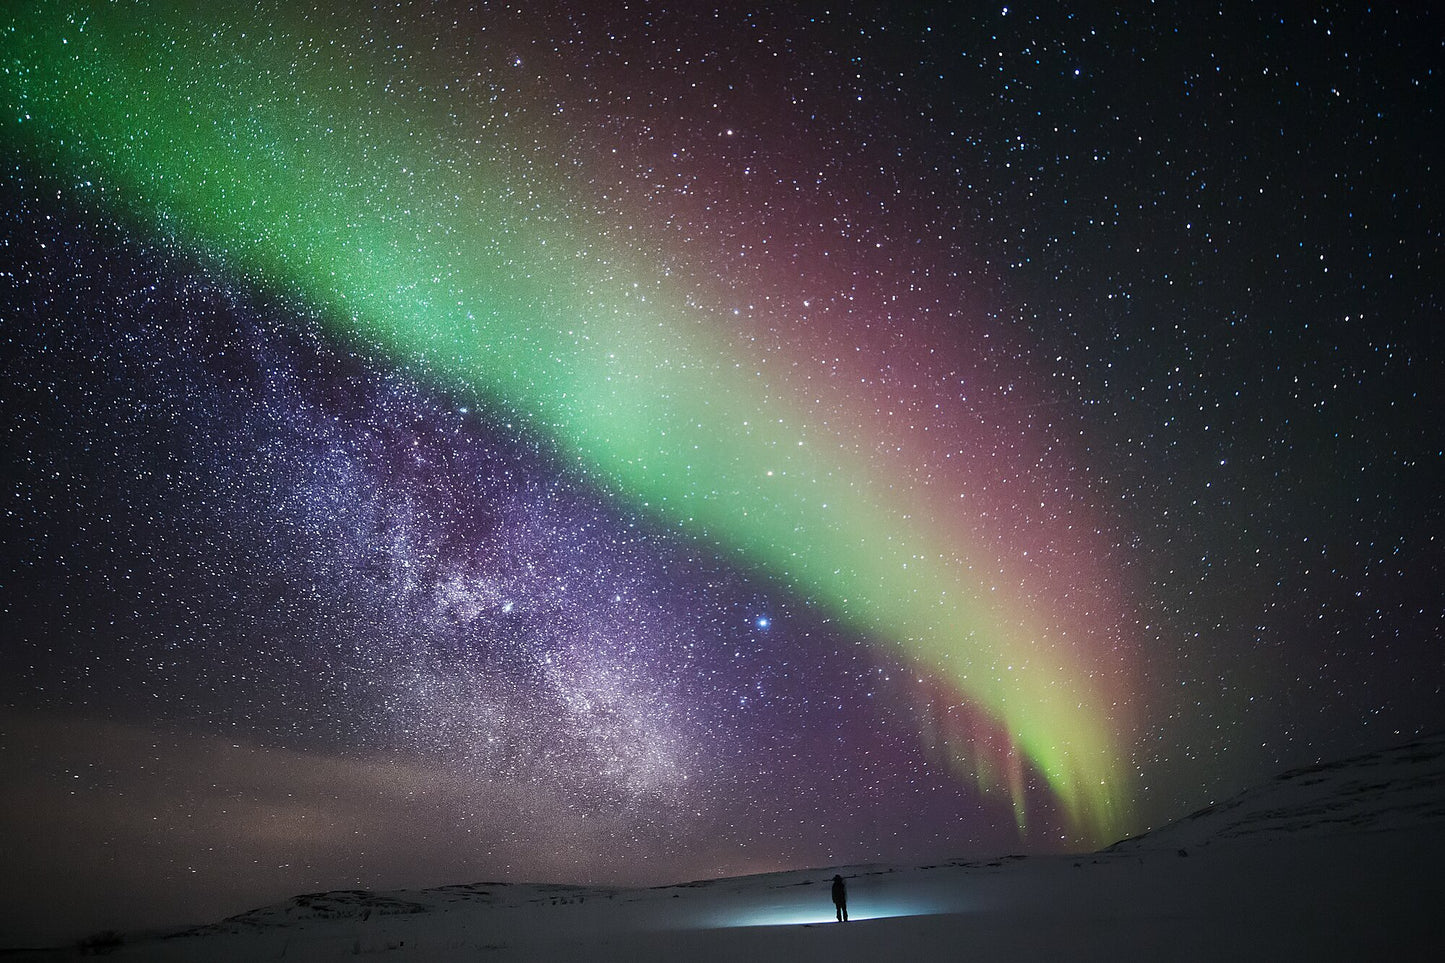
[8,4,1131,843]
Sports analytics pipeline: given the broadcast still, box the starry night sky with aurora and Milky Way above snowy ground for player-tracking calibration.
[0,1,1445,944]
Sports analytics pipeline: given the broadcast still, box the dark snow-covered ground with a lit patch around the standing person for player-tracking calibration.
[14,736,1445,963]
